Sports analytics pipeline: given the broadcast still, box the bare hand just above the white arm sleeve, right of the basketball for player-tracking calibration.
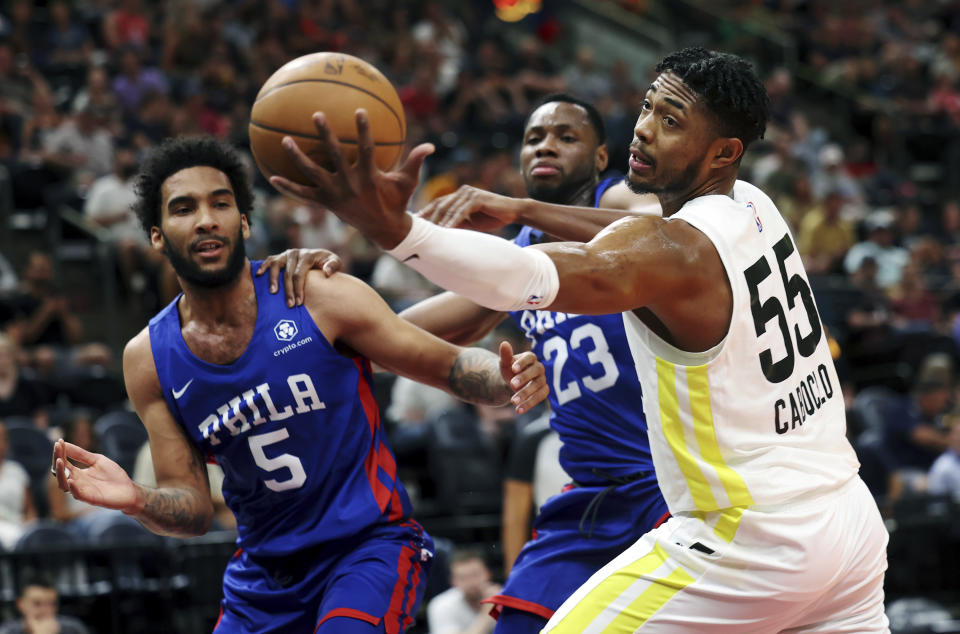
[418,185,520,231]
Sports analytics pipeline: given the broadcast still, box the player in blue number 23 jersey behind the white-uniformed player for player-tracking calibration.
[258,94,667,634]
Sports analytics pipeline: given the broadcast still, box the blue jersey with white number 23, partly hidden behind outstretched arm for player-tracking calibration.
[510,178,653,483]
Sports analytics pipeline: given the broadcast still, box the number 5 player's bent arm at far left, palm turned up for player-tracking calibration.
[54,330,213,537]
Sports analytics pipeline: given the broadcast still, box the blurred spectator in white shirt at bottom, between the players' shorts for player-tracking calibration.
[427,549,500,634]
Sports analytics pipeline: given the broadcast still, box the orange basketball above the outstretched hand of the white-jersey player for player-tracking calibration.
[250,53,407,185]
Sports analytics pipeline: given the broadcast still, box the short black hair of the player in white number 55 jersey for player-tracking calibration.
[656,46,770,150]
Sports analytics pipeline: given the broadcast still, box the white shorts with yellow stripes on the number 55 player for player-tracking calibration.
[543,477,889,634]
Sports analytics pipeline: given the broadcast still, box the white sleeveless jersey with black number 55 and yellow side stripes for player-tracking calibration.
[624,181,859,512]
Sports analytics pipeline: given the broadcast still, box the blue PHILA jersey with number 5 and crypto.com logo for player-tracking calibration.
[150,262,410,557]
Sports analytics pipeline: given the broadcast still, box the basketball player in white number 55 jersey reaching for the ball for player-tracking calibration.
[271,48,888,634]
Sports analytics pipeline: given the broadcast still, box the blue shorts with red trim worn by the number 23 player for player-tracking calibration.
[484,473,669,632]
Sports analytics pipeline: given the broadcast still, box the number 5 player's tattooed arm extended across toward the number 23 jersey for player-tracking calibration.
[305,273,547,413]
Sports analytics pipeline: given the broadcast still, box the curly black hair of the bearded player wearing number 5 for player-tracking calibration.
[133,136,253,236]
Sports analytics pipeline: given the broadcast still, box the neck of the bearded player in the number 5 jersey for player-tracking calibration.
[177,260,257,325]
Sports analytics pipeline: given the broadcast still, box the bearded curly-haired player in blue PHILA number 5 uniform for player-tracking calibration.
[54,138,547,634]
